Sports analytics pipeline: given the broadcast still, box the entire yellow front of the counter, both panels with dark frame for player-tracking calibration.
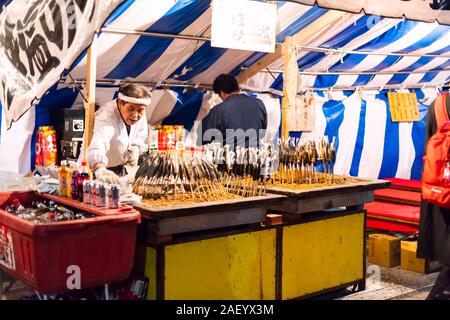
[136,211,366,300]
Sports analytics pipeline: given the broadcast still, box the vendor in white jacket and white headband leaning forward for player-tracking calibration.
[87,84,151,184]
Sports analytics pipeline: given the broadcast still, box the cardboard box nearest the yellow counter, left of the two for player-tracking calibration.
[368,233,401,268]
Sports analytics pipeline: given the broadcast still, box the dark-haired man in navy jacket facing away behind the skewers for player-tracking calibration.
[201,74,267,148]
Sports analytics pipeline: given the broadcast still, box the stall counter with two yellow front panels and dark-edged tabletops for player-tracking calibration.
[134,138,389,300]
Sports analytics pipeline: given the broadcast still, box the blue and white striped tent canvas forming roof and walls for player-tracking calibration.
[0,0,450,179]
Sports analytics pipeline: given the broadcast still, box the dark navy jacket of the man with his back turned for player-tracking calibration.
[199,94,267,147]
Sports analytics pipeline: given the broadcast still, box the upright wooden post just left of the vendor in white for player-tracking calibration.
[83,34,97,160]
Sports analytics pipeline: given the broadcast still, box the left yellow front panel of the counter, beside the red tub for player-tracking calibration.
[139,229,276,300]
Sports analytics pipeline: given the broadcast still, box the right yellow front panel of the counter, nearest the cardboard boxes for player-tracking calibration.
[282,212,365,300]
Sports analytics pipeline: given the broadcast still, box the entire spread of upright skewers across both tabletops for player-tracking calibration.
[133,138,336,201]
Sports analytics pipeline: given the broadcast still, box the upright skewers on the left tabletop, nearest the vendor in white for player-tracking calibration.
[133,145,273,201]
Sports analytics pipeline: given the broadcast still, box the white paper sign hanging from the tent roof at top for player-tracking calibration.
[211,0,277,52]
